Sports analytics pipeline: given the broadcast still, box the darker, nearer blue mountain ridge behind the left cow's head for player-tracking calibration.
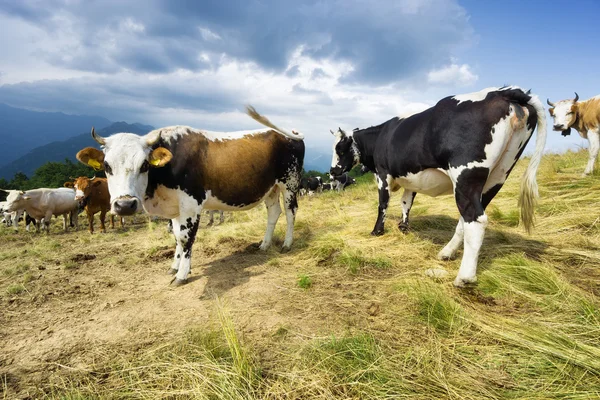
[0,122,154,180]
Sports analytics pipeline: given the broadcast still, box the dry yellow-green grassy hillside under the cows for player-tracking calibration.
[0,148,600,399]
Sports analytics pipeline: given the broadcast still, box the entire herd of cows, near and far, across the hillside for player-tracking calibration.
[0,86,600,287]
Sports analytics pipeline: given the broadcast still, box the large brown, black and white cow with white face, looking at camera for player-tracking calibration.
[77,107,304,285]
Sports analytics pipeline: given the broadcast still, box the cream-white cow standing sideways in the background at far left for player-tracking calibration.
[6,188,79,233]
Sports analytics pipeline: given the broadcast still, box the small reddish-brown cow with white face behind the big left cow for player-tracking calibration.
[65,176,123,234]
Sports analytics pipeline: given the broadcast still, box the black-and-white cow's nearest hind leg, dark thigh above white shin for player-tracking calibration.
[449,167,489,287]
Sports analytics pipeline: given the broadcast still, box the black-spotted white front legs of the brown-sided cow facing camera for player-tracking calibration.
[171,210,201,286]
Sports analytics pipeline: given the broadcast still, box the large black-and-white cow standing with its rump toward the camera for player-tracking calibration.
[331,86,546,286]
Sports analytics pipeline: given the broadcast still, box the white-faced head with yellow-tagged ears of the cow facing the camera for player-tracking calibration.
[77,128,173,215]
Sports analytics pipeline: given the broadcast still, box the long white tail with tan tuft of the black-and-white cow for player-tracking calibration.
[519,95,546,233]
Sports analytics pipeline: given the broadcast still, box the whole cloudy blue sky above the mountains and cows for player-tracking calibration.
[0,0,600,151]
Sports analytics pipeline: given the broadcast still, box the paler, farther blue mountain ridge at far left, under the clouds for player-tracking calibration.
[0,104,112,165]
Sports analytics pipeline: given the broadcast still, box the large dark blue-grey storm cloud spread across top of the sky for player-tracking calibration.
[0,0,472,84]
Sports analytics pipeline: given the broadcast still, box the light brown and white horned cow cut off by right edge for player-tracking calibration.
[546,92,600,176]
